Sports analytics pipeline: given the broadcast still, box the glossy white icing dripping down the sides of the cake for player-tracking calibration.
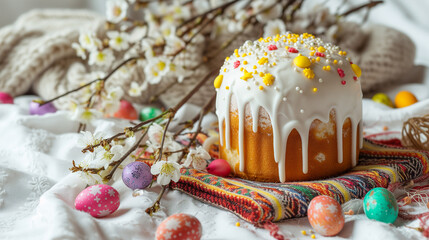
[216,33,362,182]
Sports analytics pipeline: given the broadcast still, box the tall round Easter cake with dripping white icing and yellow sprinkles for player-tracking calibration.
[214,33,362,182]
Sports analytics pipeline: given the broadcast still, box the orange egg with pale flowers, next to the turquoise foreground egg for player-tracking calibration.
[307,195,344,236]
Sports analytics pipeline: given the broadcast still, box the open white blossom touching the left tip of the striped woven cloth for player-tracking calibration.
[150,161,182,186]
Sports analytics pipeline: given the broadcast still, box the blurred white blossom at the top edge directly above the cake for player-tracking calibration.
[251,0,282,23]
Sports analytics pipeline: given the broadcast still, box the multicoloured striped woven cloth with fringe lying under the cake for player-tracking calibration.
[171,139,429,224]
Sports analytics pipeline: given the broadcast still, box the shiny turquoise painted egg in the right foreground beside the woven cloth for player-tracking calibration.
[363,188,398,223]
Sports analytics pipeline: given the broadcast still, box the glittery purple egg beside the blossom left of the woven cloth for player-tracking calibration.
[122,161,152,190]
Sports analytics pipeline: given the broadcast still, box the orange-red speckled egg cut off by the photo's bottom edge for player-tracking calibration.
[155,213,203,240]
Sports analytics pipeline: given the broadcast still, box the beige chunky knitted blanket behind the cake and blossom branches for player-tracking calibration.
[0,10,415,109]
